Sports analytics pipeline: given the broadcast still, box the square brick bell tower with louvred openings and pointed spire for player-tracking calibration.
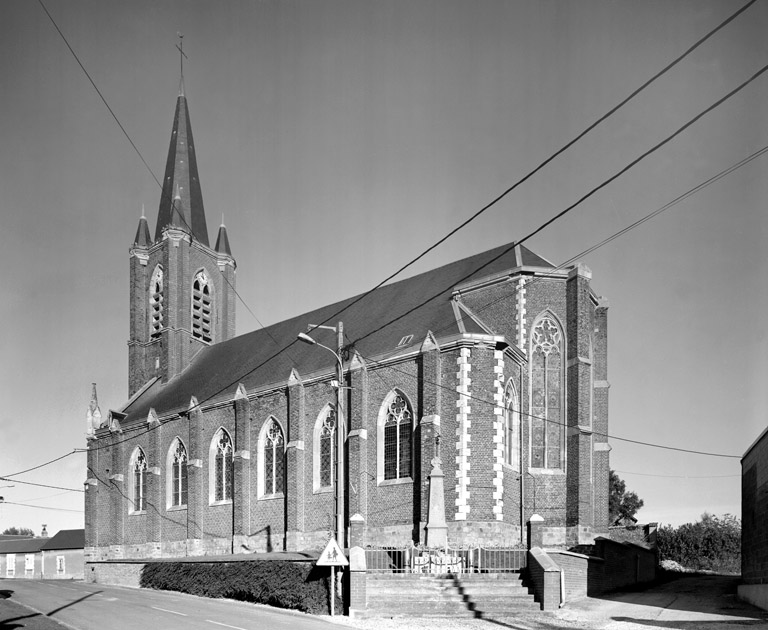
[128,70,236,396]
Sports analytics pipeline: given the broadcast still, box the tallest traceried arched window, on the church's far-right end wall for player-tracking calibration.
[531,315,565,468]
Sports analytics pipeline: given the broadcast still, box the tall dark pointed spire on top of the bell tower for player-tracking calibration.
[155,89,209,246]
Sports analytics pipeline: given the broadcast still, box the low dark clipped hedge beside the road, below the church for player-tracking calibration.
[140,560,341,614]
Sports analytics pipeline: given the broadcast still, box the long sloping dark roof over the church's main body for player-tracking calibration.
[121,245,553,425]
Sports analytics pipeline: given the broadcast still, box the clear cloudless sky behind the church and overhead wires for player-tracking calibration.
[0,0,768,533]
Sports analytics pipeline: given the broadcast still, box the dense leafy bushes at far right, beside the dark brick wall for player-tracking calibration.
[657,512,741,573]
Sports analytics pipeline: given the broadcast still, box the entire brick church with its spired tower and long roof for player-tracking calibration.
[85,80,610,559]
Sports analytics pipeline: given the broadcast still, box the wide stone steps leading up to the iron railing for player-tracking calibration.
[362,573,541,618]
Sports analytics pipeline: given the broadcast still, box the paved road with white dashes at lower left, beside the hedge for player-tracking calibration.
[0,579,338,630]
